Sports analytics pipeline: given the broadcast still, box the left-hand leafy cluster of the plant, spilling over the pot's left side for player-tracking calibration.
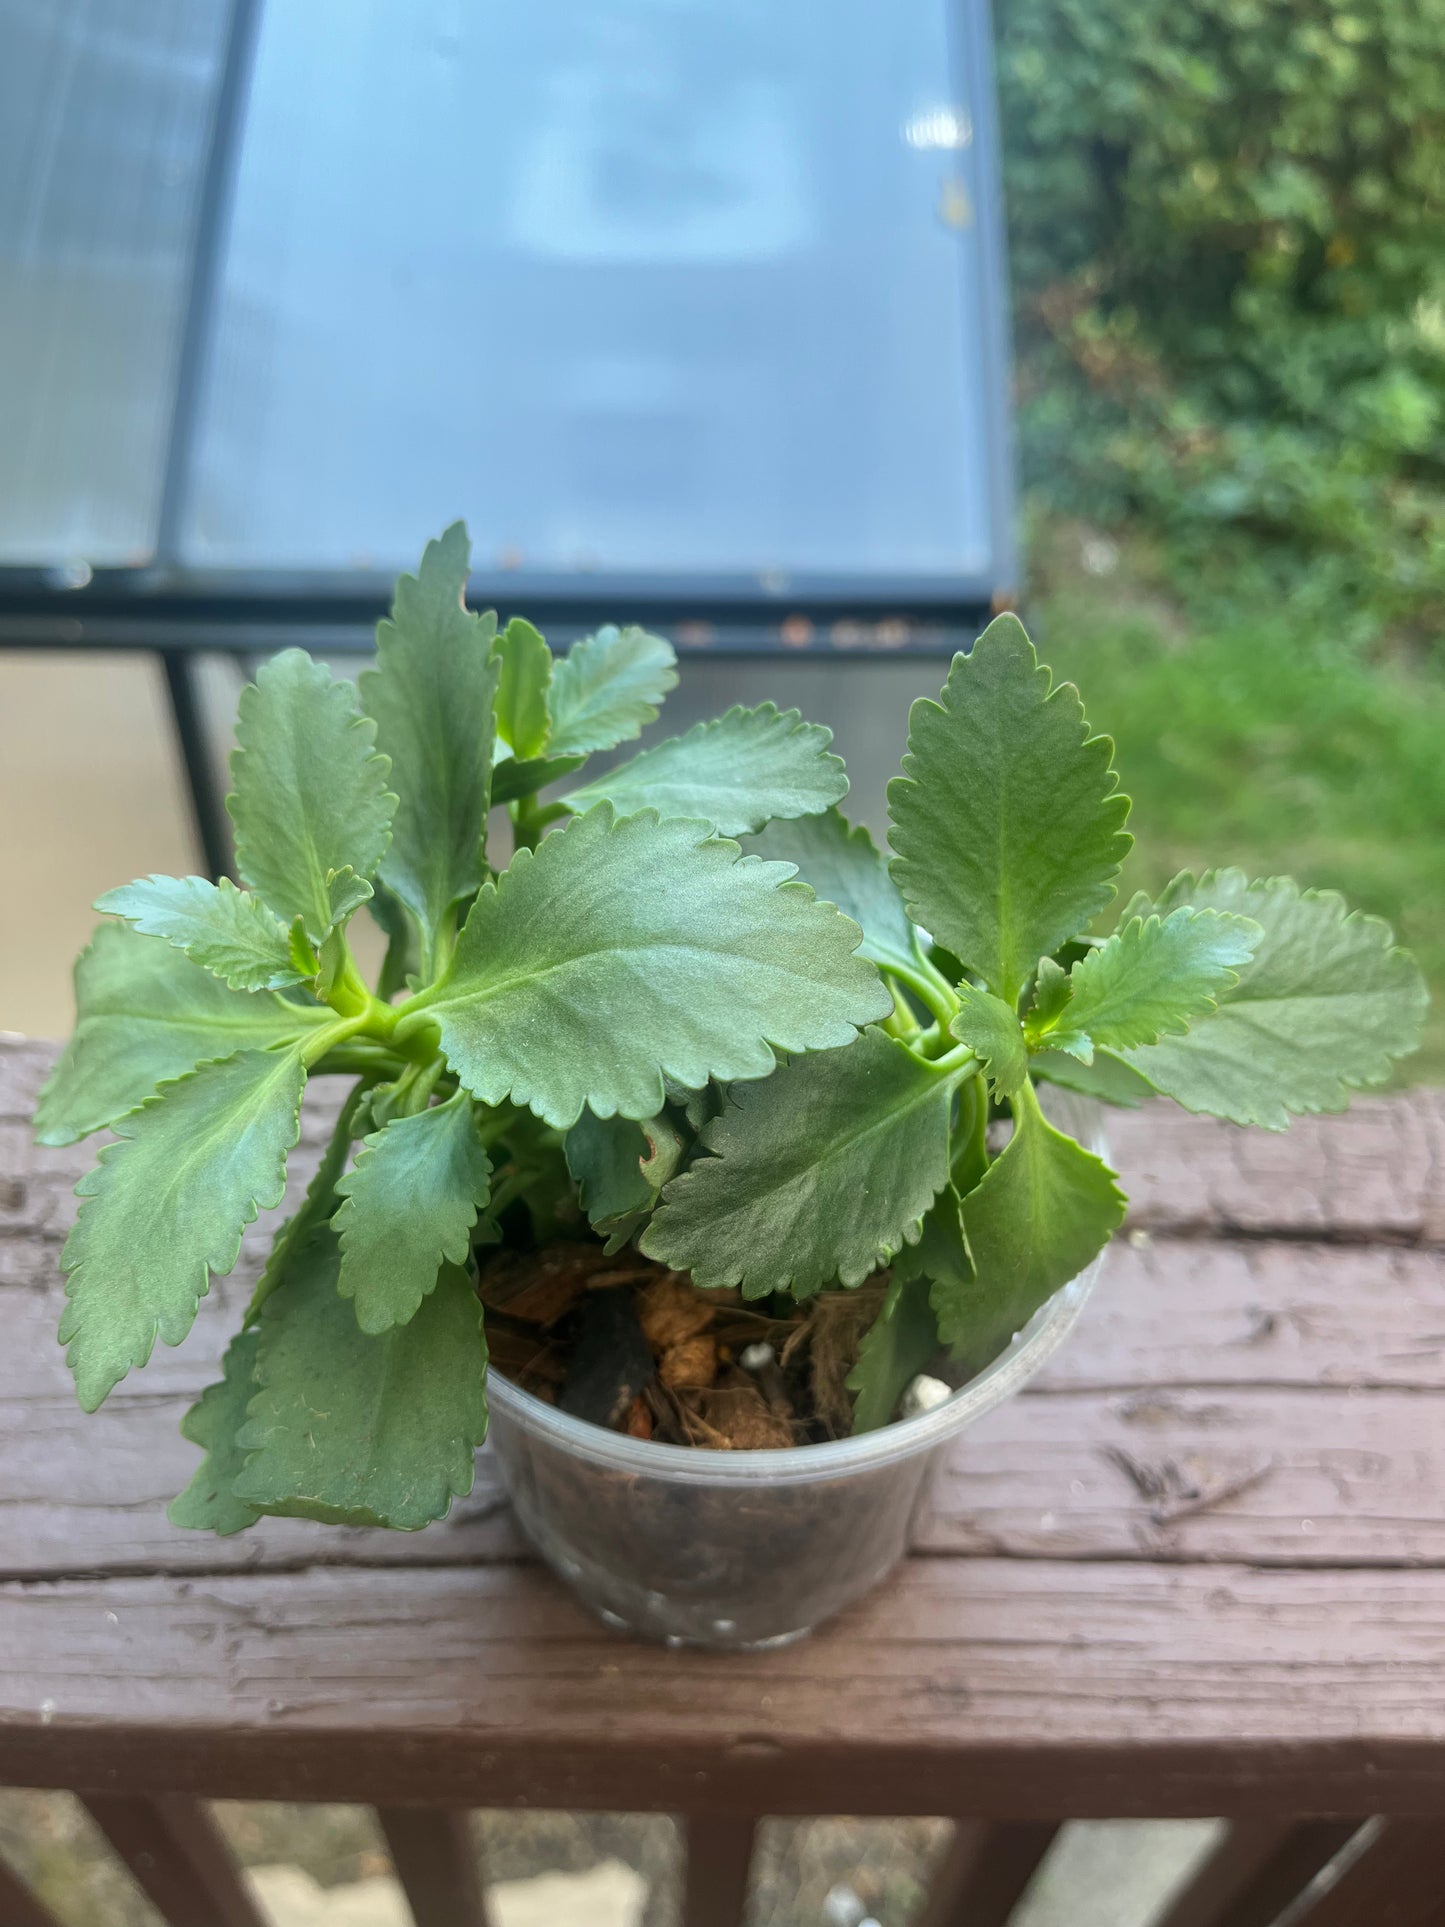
[37,524,890,1532]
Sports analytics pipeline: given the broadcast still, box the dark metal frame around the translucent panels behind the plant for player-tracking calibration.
[0,0,1015,875]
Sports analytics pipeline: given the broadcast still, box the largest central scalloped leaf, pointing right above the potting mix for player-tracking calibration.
[410,804,892,1127]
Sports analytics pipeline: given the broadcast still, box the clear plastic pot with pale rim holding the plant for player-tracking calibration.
[487,1095,1104,1651]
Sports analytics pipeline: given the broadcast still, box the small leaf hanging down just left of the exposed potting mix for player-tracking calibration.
[333,1091,491,1332]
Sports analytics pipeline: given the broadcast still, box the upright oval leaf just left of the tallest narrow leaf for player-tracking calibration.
[225,649,397,944]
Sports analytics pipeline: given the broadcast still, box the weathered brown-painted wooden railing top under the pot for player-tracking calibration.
[0,1043,1445,1819]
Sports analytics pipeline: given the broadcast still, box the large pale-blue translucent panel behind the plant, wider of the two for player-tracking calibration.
[183,0,998,576]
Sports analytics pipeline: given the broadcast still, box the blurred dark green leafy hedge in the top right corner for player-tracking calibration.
[996,0,1445,646]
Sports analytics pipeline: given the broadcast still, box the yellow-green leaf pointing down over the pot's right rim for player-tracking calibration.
[951,1081,1125,1353]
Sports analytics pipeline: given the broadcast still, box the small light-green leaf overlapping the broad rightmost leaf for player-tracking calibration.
[1035,908,1264,1064]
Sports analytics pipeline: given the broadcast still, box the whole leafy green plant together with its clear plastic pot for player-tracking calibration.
[37,524,1426,1646]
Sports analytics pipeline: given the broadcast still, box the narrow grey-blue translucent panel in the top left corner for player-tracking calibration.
[0,0,229,565]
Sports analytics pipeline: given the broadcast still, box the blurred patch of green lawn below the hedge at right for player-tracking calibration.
[1033,554,1445,1083]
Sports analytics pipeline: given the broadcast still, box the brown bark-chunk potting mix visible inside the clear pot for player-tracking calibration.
[480,1241,909,1449]
